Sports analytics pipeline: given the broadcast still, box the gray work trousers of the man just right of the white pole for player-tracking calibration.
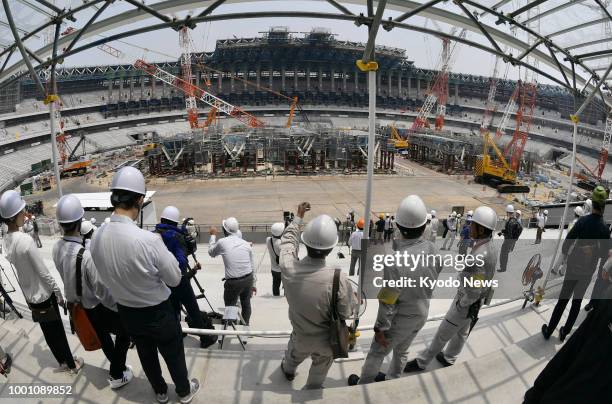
[359,317,427,384]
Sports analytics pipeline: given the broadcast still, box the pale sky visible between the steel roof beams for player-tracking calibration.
[0,0,608,87]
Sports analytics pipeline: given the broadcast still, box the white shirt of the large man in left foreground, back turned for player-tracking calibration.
[91,215,181,307]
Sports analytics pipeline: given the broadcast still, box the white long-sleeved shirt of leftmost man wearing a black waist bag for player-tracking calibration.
[4,231,62,303]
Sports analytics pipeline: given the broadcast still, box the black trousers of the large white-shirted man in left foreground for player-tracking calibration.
[117,300,191,397]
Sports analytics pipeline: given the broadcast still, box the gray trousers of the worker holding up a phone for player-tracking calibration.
[283,333,334,389]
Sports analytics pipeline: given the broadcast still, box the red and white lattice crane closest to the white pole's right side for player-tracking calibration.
[410,29,467,131]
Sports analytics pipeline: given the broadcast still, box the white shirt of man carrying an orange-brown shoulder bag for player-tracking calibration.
[53,236,117,311]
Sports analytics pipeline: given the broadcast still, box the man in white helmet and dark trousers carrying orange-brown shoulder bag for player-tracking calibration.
[53,195,134,389]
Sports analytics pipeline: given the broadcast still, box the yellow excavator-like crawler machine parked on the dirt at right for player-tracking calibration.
[474,132,529,193]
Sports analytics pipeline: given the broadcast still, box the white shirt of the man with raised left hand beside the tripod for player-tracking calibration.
[208,234,255,279]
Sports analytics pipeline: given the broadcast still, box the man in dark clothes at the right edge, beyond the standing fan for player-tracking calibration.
[542,185,612,341]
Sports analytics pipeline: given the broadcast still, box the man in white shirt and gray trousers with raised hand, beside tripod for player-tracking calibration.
[208,217,257,325]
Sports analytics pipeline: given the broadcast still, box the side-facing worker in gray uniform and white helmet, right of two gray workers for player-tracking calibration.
[404,206,497,372]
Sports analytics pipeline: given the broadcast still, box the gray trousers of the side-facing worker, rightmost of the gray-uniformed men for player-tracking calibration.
[416,300,472,369]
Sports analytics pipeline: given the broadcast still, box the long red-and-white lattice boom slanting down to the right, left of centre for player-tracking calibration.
[134,59,265,128]
